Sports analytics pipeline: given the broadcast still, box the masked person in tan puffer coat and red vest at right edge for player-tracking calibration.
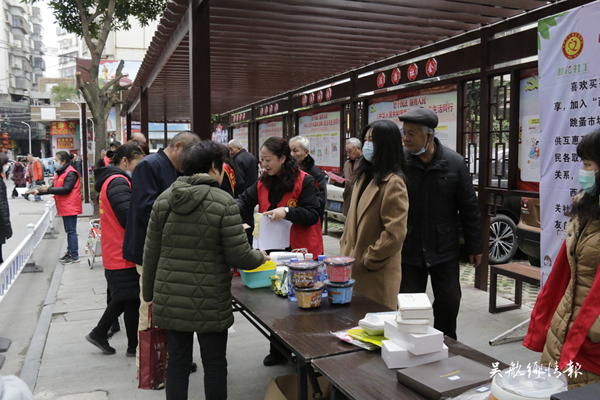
[523,130,600,390]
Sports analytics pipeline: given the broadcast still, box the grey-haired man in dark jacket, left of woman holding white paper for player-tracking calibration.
[229,139,258,245]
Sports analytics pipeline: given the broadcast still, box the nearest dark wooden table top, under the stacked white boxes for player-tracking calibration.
[312,336,509,400]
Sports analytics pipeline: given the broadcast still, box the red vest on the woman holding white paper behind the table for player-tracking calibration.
[257,171,323,260]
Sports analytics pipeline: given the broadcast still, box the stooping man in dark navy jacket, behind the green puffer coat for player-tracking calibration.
[123,131,200,365]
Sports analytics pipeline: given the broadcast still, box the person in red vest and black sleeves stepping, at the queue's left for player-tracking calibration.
[86,143,145,357]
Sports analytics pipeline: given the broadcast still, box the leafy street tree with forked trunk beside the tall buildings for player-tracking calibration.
[30,0,167,149]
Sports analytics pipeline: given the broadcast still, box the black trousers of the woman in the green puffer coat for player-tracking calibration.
[165,329,227,400]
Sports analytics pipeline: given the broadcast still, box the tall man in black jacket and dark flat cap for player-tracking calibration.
[399,107,483,339]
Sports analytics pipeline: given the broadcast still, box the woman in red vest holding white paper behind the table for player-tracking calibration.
[236,137,323,366]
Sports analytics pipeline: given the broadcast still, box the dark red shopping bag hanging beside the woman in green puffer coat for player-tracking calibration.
[138,305,167,389]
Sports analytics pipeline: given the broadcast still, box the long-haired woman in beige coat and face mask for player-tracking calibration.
[340,120,408,310]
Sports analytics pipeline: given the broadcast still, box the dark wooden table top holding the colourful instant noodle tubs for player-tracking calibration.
[231,277,392,361]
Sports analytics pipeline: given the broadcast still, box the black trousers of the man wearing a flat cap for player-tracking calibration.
[400,258,462,339]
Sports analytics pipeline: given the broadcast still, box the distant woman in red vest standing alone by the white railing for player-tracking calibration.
[33,151,81,264]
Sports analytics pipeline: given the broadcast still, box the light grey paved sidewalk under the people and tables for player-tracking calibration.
[22,219,540,400]
